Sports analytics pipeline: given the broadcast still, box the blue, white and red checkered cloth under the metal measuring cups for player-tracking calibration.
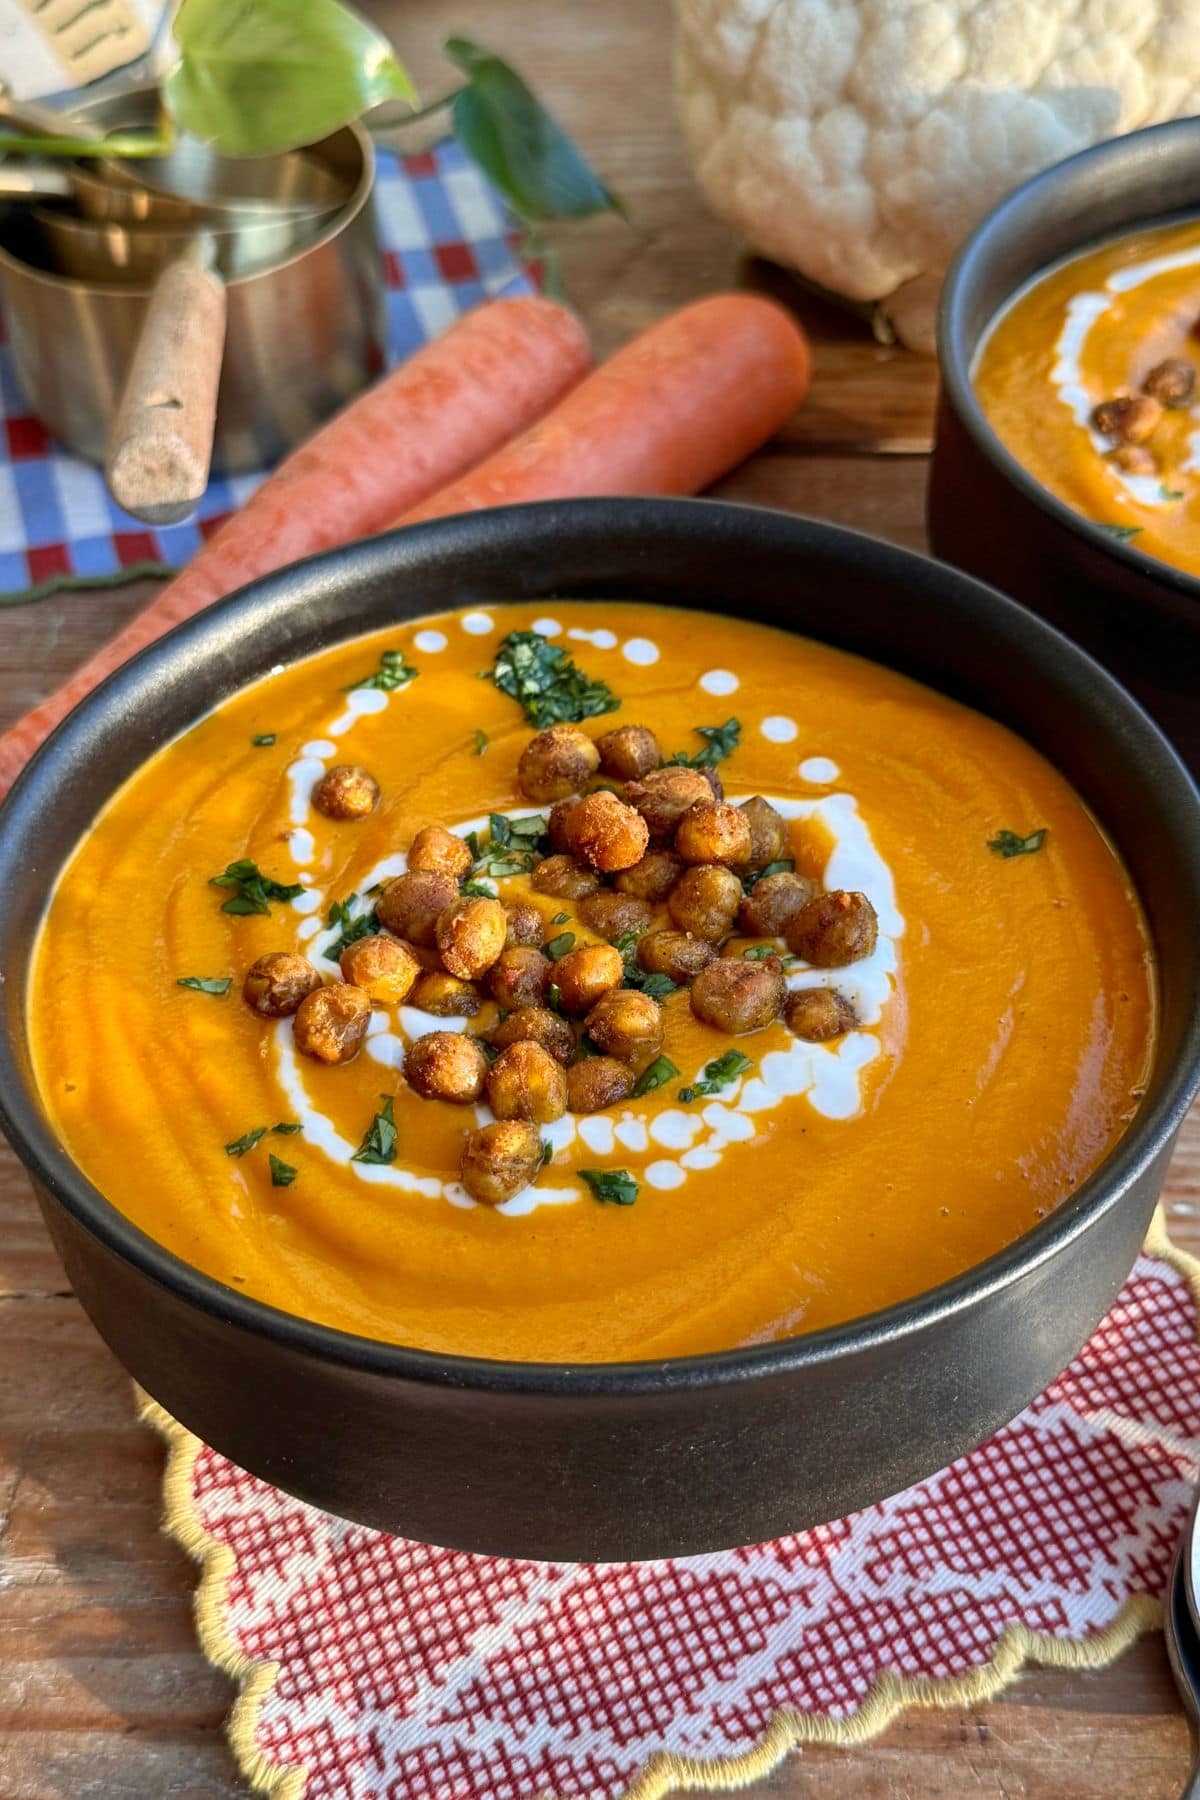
[0,140,533,605]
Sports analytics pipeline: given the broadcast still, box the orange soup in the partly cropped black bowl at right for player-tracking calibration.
[975,220,1200,574]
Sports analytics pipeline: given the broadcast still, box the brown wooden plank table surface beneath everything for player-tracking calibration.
[0,0,1200,1800]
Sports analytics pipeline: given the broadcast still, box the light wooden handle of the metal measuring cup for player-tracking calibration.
[104,247,225,526]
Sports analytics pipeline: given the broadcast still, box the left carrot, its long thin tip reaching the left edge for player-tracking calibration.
[0,297,588,797]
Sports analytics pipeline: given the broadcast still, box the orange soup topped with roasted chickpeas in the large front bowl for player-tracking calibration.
[31,601,1153,1361]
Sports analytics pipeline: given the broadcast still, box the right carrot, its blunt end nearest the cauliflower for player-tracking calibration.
[396,293,810,526]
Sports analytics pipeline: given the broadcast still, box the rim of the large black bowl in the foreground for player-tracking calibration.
[0,499,1200,1402]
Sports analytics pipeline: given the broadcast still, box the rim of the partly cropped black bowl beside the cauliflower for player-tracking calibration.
[937,117,1200,603]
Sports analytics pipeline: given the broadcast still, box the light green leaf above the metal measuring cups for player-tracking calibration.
[162,0,416,157]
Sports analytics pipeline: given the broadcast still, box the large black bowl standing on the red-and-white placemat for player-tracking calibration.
[0,500,1200,1559]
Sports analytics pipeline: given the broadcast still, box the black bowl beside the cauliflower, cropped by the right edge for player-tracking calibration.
[928,119,1200,769]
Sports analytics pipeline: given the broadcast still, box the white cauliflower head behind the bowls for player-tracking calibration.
[675,0,1200,351]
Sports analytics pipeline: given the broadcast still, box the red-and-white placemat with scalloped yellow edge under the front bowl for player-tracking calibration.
[146,1226,1200,1800]
